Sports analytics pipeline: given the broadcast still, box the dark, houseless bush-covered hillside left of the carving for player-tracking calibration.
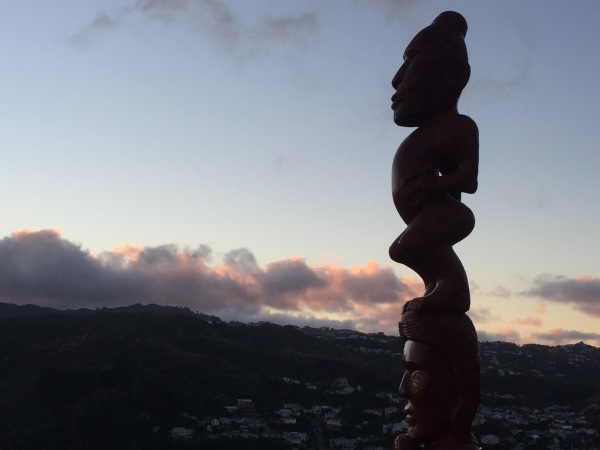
[0,305,401,449]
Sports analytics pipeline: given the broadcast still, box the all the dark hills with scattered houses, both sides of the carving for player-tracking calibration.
[0,304,600,450]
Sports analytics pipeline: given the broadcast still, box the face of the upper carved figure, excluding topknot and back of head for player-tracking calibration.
[392,28,458,127]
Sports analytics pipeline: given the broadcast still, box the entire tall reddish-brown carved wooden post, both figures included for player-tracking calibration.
[389,11,479,450]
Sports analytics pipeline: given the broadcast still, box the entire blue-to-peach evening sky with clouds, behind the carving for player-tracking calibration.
[0,0,600,346]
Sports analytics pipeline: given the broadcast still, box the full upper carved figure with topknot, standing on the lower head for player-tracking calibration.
[390,11,479,312]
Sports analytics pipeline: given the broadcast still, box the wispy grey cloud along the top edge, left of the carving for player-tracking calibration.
[69,0,319,52]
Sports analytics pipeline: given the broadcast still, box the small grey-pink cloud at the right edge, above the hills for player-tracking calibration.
[525,274,600,317]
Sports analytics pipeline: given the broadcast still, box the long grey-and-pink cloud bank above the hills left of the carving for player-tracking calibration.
[0,230,422,333]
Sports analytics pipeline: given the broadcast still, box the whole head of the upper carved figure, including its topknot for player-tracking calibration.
[392,11,471,127]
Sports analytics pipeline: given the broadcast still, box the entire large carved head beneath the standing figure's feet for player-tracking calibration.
[399,311,479,444]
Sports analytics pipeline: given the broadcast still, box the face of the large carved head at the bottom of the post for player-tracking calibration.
[399,341,456,443]
